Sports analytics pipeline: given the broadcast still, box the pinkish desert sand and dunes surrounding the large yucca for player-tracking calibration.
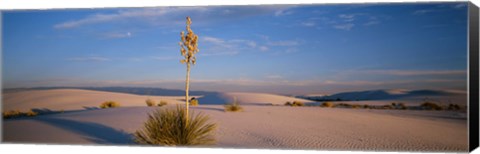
[3,89,468,152]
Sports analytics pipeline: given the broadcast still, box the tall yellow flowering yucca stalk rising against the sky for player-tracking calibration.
[179,17,199,124]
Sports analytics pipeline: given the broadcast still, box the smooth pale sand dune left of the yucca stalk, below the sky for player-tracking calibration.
[2,89,184,111]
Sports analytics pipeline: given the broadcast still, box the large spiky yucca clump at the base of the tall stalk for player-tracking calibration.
[134,106,217,146]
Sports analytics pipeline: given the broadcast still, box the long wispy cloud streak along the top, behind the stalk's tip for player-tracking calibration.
[53,5,295,29]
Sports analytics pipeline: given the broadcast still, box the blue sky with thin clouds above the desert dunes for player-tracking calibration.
[2,2,467,94]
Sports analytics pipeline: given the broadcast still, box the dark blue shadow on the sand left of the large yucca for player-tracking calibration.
[34,117,133,144]
